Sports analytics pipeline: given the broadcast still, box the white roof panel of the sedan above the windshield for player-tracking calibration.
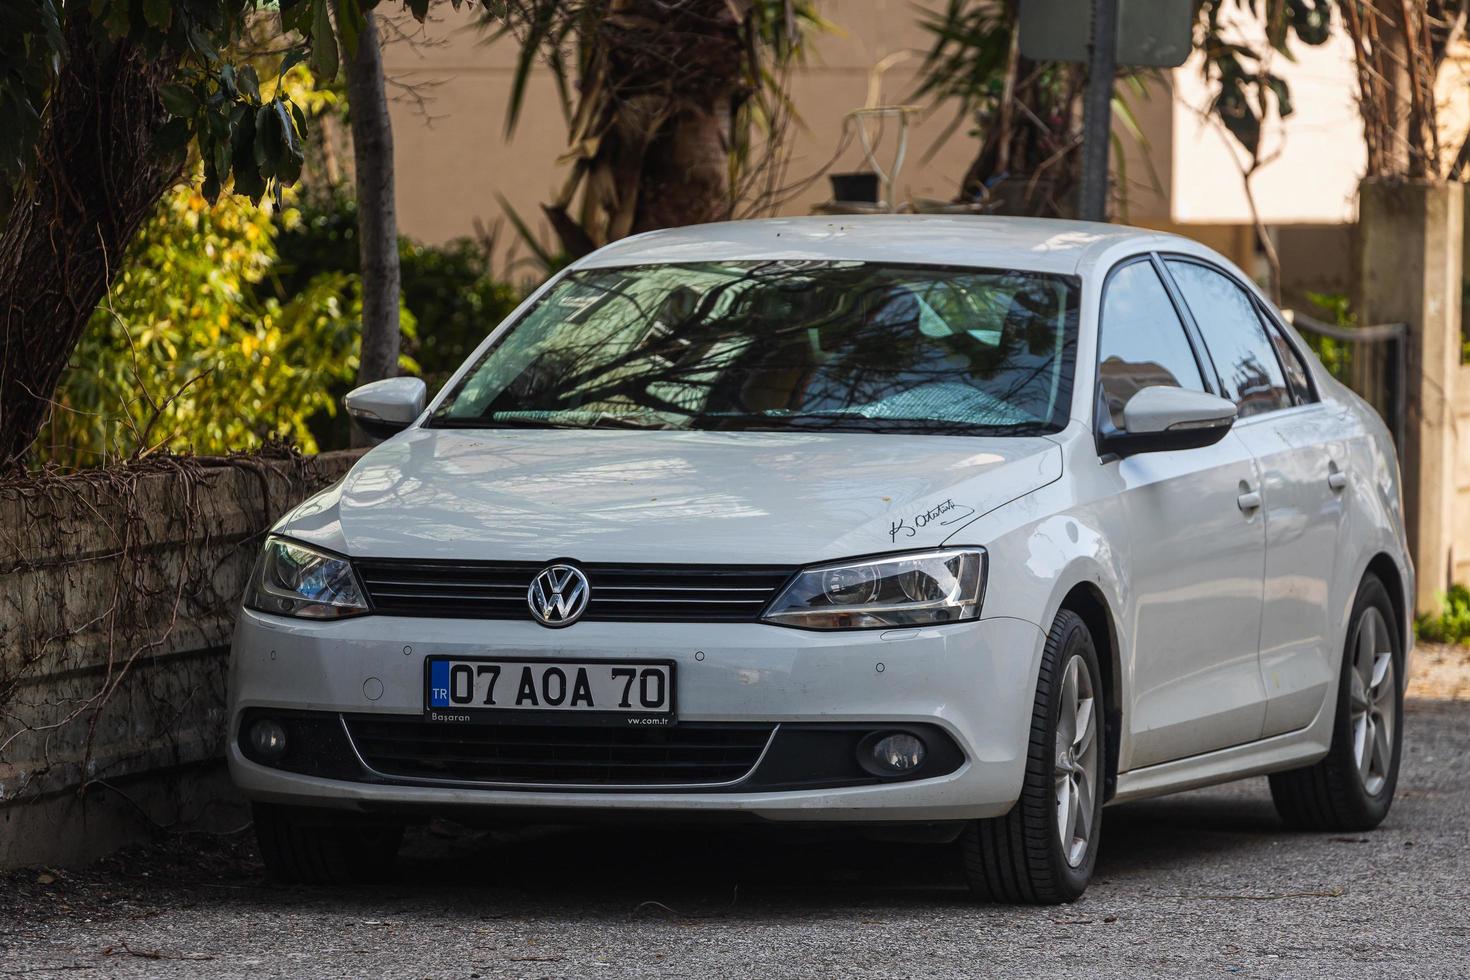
[576,215,1194,275]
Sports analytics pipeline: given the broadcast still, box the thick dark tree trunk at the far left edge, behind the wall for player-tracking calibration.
[0,4,179,467]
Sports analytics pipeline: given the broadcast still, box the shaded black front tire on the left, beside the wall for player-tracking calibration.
[251,804,403,884]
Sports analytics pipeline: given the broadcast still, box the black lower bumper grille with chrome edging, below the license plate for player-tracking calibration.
[345,716,775,786]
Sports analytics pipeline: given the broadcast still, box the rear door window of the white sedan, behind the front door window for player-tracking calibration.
[1169,260,1292,419]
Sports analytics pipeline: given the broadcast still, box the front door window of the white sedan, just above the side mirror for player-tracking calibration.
[1098,260,1204,429]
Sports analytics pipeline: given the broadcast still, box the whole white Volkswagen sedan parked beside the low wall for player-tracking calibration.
[229,216,1413,902]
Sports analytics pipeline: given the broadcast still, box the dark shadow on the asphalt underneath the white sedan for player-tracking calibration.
[289,780,1289,915]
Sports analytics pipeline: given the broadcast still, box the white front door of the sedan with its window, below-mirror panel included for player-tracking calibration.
[1097,257,1266,768]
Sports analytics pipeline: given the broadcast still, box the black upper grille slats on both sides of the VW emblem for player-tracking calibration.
[354,558,794,623]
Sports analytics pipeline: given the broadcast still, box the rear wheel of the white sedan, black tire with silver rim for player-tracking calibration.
[1270,574,1404,830]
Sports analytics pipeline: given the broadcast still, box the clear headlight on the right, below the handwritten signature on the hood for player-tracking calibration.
[763,548,985,629]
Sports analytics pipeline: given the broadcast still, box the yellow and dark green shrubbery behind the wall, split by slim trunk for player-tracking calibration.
[37,185,517,466]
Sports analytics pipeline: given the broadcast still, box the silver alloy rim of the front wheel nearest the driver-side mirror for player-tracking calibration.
[1053,657,1098,867]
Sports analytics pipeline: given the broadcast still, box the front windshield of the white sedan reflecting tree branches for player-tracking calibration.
[429,262,1078,435]
